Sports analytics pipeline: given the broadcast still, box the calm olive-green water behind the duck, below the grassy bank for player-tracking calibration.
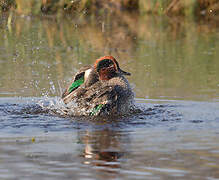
[0,15,219,100]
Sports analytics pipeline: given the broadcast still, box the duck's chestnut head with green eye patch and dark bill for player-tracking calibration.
[94,56,131,80]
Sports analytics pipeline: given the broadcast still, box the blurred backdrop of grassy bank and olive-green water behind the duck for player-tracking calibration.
[0,0,219,100]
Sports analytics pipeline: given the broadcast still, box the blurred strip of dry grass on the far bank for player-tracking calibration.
[0,0,219,18]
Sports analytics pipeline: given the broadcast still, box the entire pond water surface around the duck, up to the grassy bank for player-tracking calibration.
[0,14,219,180]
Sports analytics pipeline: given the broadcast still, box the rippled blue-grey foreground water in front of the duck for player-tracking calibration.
[0,97,219,180]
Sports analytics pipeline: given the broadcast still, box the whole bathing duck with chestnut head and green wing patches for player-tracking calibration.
[62,56,134,116]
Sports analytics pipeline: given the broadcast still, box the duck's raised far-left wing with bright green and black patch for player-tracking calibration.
[62,65,92,98]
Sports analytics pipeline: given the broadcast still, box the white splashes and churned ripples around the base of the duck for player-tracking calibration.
[37,97,182,124]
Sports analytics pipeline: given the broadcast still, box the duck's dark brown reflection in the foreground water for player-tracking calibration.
[79,129,127,178]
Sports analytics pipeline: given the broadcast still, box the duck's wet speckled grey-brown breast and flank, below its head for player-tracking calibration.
[75,76,134,114]
